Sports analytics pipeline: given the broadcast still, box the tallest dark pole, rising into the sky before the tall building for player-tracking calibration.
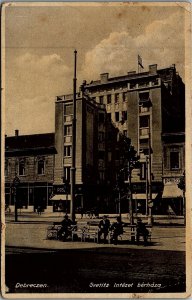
[70,50,77,222]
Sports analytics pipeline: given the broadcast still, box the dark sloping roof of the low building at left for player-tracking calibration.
[5,133,57,156]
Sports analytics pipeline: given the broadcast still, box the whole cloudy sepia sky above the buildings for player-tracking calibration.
[4,3,186,136]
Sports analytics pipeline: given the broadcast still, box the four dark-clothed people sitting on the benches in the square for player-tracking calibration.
[58,214,149,245]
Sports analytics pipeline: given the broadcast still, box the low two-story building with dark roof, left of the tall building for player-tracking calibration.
[5,130,56,211]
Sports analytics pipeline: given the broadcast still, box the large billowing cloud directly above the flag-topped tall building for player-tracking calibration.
[83,13,184,80]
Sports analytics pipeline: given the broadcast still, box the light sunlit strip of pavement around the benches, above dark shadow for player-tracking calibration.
[5,221,185,251]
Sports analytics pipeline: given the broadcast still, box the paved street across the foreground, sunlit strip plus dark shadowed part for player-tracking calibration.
[3,217,185,293]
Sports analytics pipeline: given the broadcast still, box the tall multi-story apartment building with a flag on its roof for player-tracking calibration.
[54,65,185,213]
